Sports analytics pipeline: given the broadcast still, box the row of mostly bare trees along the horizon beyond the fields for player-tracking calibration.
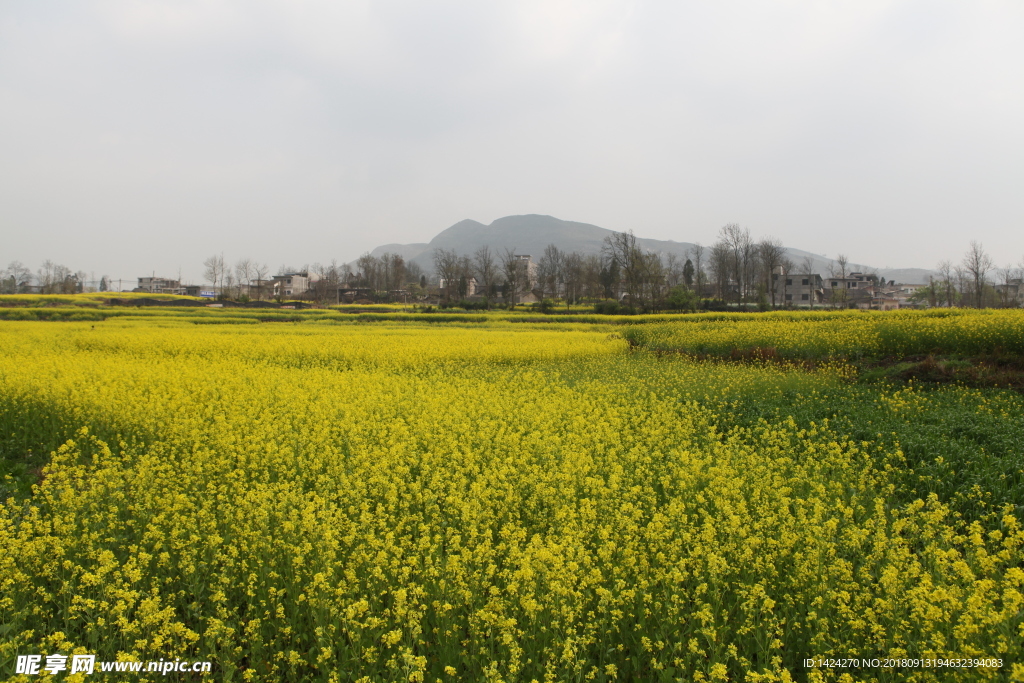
[12,236,1024,310]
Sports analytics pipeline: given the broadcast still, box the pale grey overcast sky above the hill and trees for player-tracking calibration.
[0,0,1024,282]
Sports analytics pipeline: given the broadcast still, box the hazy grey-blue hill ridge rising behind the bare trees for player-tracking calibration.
[371,214,934,283]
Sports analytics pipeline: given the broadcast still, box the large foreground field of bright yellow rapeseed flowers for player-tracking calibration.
[0,321,1024,682]
